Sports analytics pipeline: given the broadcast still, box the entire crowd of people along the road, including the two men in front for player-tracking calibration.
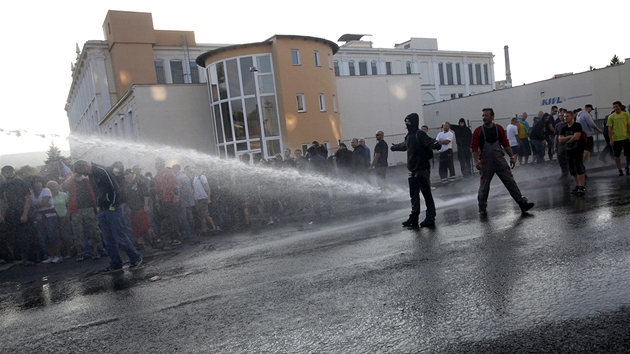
[0,101,630,272]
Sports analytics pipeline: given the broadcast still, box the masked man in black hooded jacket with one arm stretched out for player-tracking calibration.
[391,113,439,228]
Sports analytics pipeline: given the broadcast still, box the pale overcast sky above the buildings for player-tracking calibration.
[0,0,630,155]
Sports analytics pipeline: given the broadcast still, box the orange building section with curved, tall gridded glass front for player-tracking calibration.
[196,35,341,158]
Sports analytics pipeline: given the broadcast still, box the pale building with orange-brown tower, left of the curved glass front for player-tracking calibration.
[65,11,221,156]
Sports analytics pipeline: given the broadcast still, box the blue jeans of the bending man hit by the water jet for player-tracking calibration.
[96,207,142,268]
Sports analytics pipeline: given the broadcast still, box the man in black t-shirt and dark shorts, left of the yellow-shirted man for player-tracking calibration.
[558,111,586,195]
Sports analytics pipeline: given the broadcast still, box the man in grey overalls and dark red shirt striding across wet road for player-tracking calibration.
[471,108,534,216]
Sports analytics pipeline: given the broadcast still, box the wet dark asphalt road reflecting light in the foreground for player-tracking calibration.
[0,162,630,353]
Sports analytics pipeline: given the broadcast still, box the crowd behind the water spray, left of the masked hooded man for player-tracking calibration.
[0,131,396,272]
